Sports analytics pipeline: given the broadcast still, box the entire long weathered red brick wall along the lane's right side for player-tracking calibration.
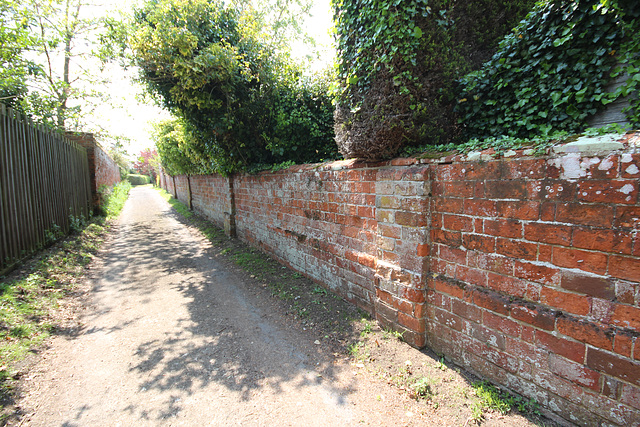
[165,134,640,425]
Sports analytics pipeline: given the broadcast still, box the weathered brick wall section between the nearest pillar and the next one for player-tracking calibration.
[234,162,378,311]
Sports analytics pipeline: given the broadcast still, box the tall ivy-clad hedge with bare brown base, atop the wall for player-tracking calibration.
[333,0,534,159]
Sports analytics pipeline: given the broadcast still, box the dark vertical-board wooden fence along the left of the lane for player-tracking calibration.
[0,105,91,274]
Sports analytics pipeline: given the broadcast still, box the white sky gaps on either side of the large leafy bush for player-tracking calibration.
[84,0,334,159]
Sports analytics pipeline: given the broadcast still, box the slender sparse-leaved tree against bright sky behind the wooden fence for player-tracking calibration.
[0,0,127,130]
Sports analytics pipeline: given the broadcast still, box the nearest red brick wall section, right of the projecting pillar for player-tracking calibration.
[427,137,640,425]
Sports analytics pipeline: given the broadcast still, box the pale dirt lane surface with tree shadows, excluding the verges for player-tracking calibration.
[13,188,439,426]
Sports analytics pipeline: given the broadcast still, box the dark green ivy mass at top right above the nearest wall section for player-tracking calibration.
[457,0,640,138]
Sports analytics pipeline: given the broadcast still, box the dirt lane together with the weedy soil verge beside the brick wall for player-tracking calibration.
[2,187,553,426]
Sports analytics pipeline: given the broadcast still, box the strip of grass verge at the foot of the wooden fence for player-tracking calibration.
[0,183,131,414]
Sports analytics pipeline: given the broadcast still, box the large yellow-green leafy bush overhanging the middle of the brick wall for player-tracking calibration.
[131,0,335,174]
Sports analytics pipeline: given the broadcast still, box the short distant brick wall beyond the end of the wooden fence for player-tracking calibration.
[66,132,120,207]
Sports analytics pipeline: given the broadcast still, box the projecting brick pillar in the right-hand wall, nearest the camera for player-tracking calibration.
[374,165,431,348]
